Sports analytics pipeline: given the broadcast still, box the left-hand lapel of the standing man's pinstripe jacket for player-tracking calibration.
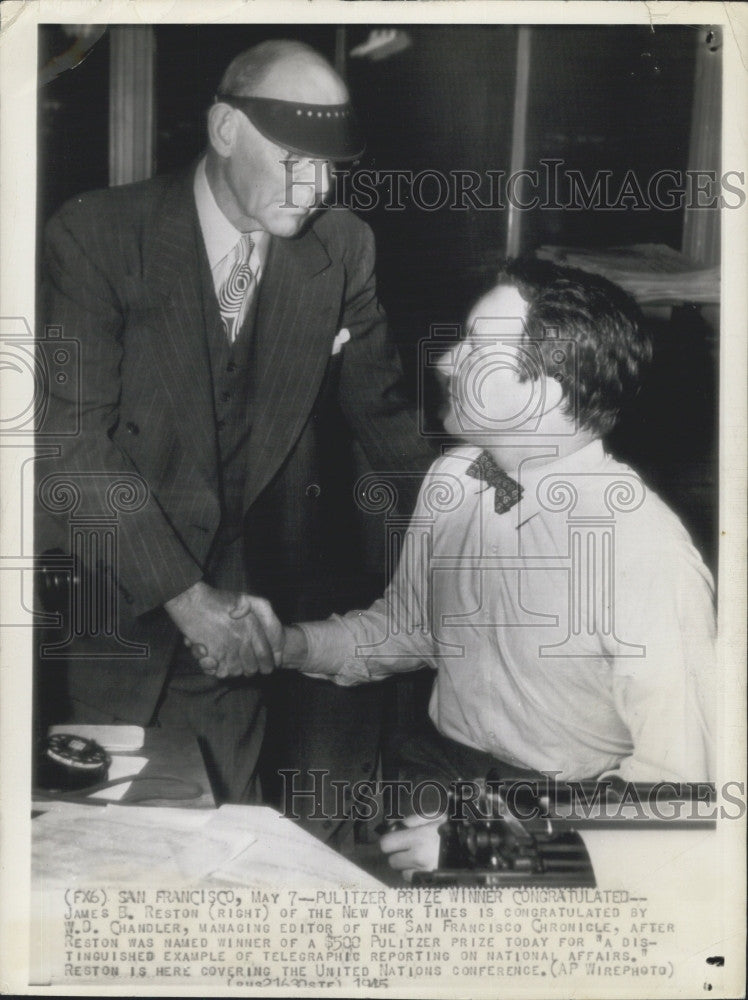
[144,170,217,480]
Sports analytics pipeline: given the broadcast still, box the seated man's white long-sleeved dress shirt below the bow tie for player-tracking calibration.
[302,441,715,781]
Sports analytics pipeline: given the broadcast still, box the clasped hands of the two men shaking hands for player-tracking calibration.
[164,581,283,678]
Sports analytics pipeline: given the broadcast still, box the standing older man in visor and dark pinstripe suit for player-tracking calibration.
[37,41,429,801]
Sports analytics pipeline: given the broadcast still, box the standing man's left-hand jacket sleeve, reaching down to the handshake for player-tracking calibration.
[38,206,202,615]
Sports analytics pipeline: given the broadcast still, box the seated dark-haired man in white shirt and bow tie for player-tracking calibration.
[284,262,714,870]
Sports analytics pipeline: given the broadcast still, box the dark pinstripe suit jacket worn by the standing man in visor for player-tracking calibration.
[37,171,430,724]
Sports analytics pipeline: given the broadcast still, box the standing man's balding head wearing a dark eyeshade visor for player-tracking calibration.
[206,40,356,237]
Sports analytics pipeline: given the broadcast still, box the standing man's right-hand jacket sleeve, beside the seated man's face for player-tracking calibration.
[340,223,434,500]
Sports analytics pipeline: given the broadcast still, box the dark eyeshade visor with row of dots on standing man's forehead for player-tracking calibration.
[216,93,365,160]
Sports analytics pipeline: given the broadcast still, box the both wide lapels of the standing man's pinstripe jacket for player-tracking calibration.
[144,169,343,509]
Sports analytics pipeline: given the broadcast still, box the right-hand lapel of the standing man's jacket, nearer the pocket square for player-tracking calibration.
[244,223,343,510]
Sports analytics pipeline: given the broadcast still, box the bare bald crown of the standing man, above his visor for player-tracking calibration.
[219,40,348,104]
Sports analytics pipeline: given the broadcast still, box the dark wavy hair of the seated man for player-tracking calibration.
[498,258,652,436]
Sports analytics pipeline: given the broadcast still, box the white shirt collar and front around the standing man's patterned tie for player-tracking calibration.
[194,159,270,329]
